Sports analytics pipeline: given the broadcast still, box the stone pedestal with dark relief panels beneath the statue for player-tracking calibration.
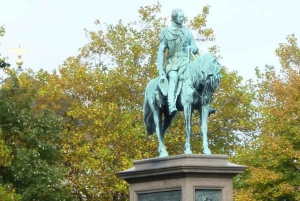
[117,154,246,201]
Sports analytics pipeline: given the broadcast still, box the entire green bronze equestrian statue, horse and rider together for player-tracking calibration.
[143,9,221,157]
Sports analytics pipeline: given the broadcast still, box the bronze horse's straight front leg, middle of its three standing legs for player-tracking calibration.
[184,104,193,154]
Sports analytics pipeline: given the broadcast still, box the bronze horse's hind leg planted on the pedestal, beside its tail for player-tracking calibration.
[153,112,169,157]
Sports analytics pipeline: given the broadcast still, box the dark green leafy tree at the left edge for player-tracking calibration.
[0,75,71,201]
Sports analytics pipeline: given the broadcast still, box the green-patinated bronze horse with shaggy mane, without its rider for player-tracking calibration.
[143,53,222,157]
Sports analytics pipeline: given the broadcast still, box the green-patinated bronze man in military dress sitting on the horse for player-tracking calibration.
[157,9,198,114]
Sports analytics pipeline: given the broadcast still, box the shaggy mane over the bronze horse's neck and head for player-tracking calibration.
[189,52,221,87]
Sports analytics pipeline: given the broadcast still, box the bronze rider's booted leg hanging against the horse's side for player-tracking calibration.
[168,71,178,114]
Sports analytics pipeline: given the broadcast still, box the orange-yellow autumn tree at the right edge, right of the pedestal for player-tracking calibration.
[236,35,300,201]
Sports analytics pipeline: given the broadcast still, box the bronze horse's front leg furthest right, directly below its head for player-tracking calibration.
[201,104,211,154]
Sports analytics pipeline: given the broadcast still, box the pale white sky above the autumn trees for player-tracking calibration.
[0,0,300,79]
